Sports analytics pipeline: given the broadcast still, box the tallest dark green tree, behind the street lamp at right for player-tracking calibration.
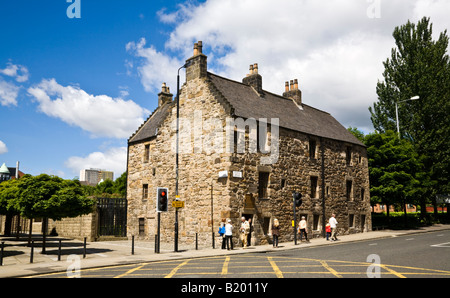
[369,18,450,213]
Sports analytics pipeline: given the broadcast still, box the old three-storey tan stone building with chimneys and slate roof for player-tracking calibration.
[127,42,371,246]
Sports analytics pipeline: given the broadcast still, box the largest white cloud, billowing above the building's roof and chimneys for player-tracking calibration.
[140,0,450,129]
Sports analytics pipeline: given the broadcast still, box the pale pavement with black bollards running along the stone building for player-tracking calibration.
[0,224,450,278]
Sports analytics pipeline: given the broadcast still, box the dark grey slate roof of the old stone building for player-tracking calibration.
[128,72,364,146]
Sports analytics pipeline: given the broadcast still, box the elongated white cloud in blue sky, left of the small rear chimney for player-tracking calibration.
[28,79,149,138]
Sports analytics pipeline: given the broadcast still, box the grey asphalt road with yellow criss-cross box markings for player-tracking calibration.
[28,231,450,278]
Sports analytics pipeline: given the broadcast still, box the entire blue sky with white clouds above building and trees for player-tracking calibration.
[0,0,450,179]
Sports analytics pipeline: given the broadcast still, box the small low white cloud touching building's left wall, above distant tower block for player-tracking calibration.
[65,147,127,179]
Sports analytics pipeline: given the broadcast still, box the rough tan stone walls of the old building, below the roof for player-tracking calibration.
[128,72,371,246]
